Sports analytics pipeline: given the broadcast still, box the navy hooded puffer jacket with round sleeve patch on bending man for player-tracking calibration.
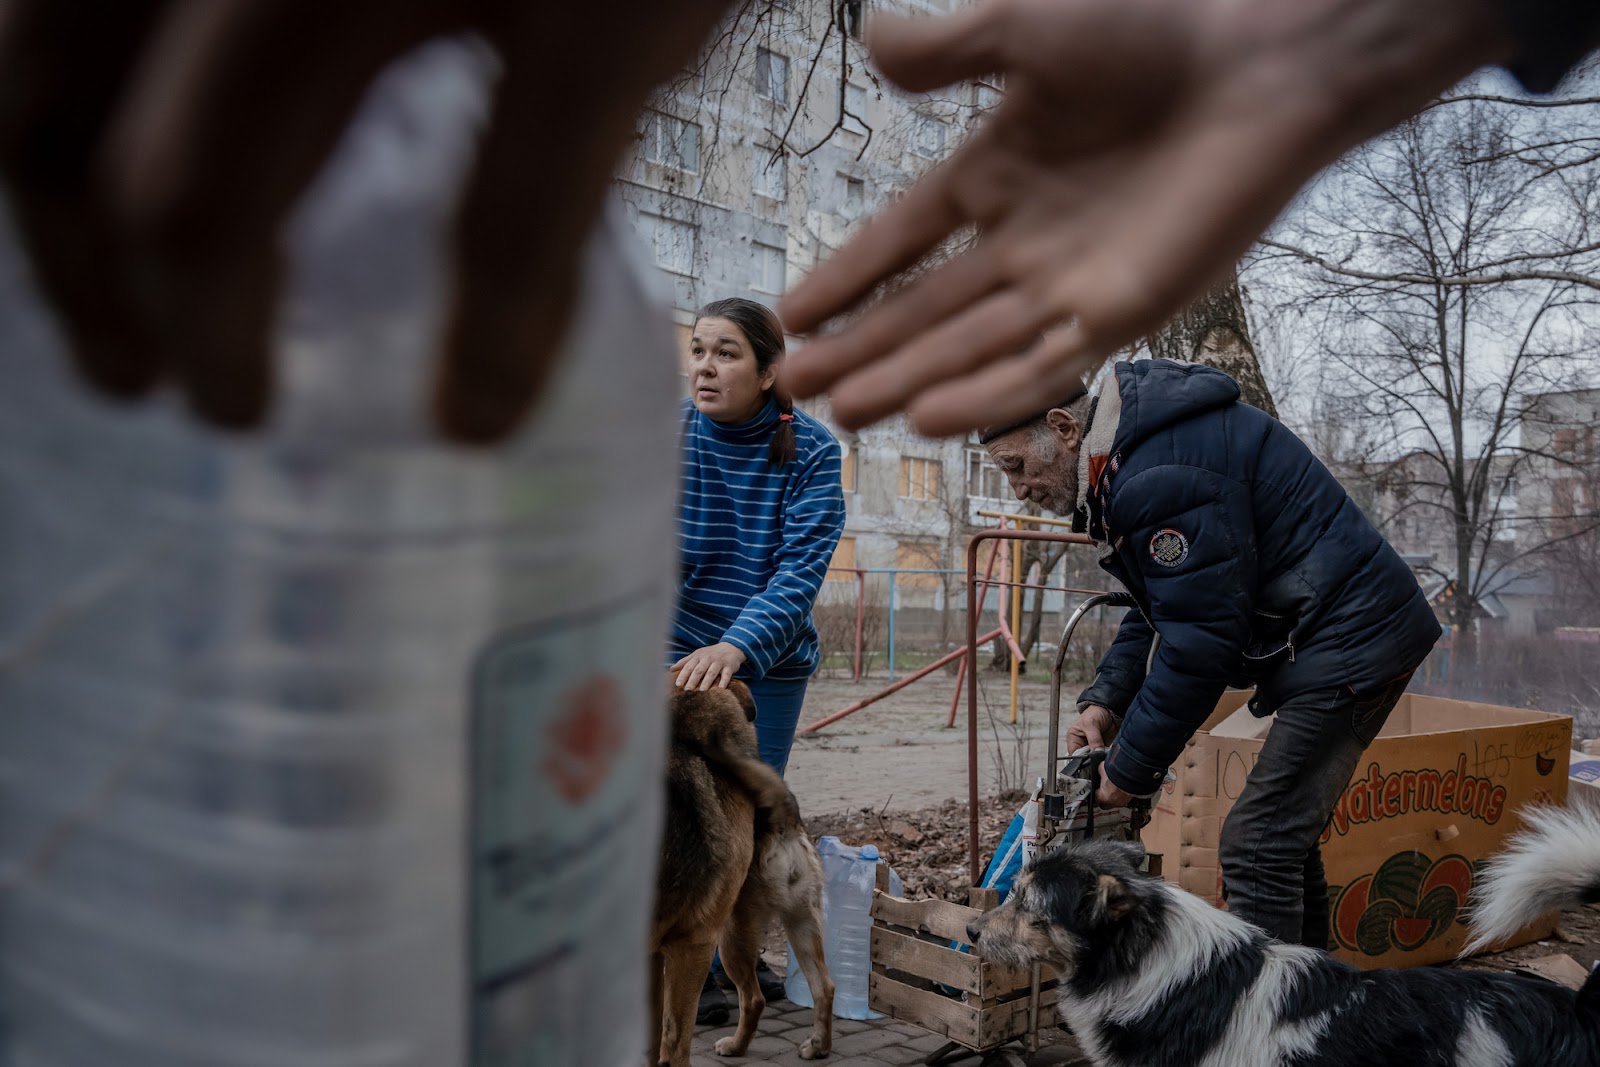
[1078,360,1440,793]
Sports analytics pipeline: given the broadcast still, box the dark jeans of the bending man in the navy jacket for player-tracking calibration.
[1218,673,1411,949]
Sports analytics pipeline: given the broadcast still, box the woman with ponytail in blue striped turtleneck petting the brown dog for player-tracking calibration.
[670,299,845,774]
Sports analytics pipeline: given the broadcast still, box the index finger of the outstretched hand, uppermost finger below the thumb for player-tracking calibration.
[778,154,971,350]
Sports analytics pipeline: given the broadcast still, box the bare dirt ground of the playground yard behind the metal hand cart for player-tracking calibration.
[784,673,1600,969]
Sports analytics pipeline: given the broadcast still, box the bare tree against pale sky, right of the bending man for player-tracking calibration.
[1248,96,1600,624]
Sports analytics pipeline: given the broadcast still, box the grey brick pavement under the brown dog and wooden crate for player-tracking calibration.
[693,1000,1088,1067]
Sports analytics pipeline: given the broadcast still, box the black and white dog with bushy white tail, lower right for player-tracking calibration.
[968,808,1600,1067]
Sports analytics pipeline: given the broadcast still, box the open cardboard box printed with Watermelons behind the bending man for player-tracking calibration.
[1144,693,1573,968]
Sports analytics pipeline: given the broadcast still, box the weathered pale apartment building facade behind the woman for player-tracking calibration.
[618,0,1000,609]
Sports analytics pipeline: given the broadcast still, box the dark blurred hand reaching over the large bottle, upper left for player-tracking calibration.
[0,0,726,442]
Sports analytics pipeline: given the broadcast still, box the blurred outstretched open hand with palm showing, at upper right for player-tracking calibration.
[779,0,1509,435]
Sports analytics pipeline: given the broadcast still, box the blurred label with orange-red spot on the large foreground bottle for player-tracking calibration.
[470,590,666,1067]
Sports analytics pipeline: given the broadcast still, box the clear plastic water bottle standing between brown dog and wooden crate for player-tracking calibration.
[784,837,904,1019]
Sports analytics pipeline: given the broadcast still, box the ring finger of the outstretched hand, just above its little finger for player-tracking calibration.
[832,290,1045,429]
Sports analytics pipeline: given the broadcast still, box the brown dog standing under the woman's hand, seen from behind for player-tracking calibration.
[650,681,834,1067]
